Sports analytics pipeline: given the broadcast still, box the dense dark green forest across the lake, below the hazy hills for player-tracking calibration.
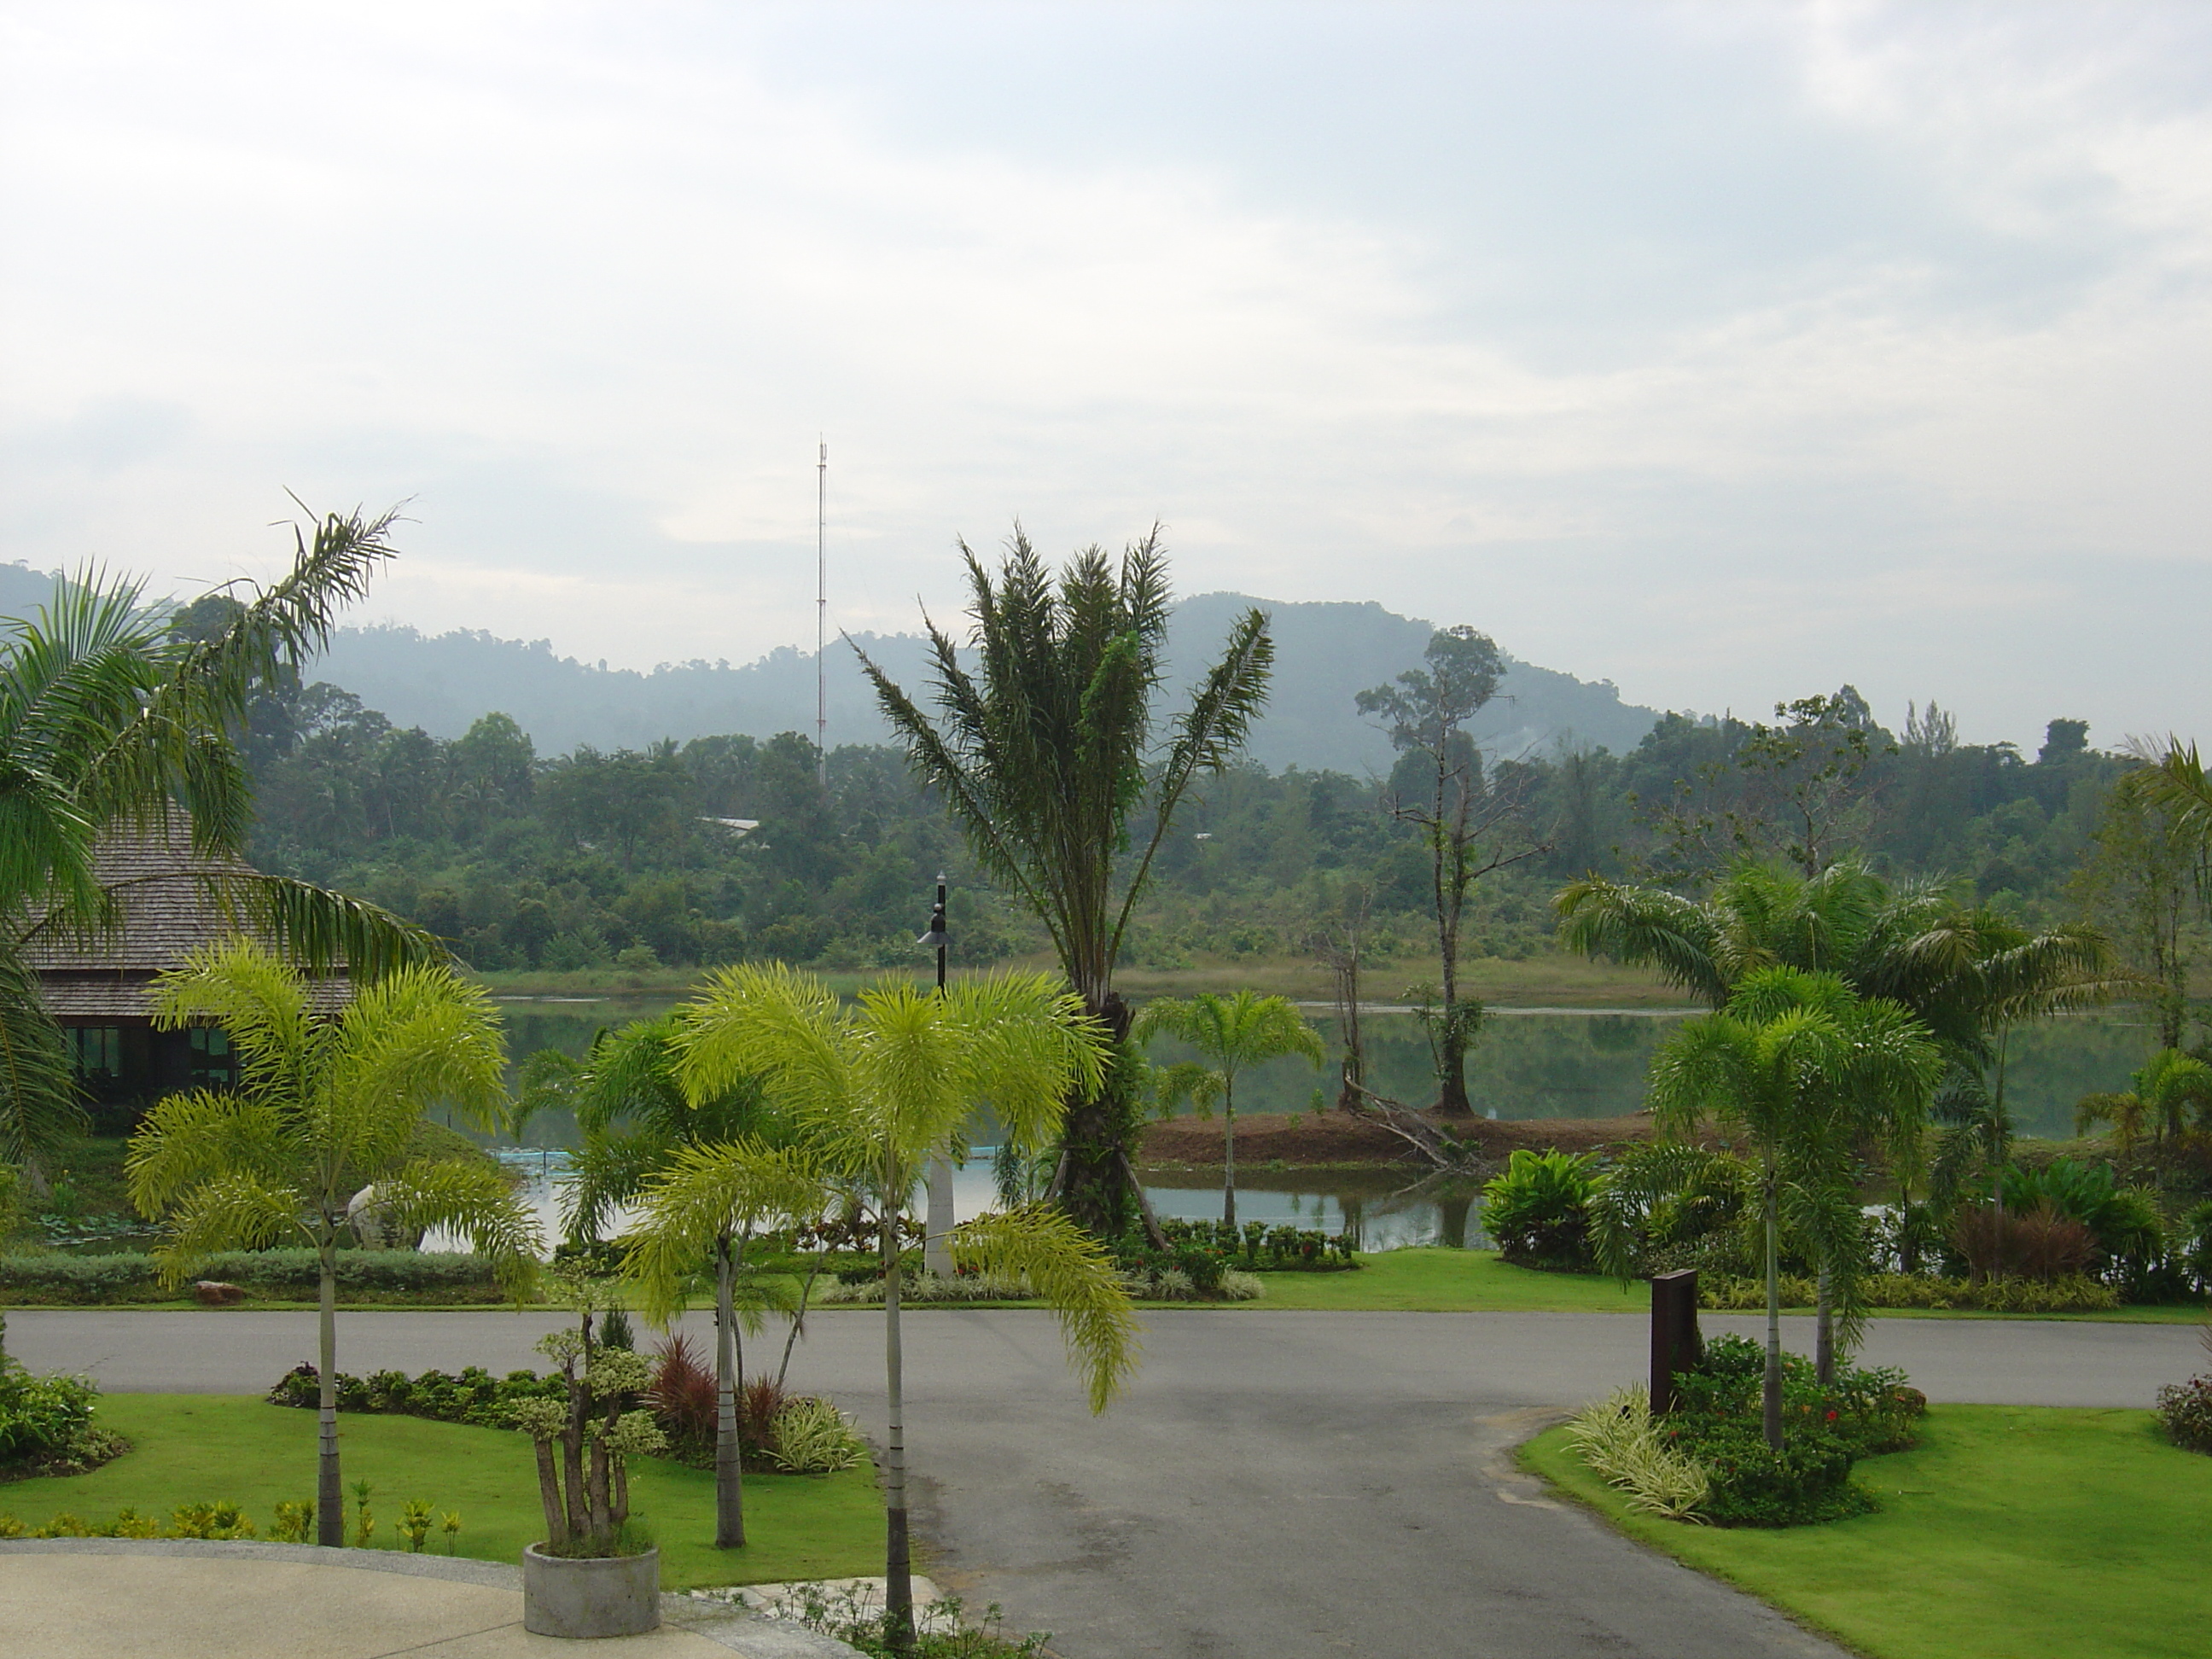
[233,641,2128,971]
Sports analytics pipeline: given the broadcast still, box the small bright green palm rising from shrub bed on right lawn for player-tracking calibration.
[1650,969,1942,1451]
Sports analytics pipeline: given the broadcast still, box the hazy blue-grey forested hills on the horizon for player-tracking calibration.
[314,593,1659,777]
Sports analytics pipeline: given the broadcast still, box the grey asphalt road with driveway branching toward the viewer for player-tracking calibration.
[9,1312,2201,1659]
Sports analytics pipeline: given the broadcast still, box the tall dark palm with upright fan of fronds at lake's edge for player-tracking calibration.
[860,527,1274,1237]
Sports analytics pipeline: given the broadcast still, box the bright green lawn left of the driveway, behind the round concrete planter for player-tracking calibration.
[0,1394,882,1591]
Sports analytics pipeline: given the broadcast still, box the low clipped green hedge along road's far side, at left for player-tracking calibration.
[0,1249,504,1307]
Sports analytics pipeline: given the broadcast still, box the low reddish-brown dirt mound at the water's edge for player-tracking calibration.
[1139,1113,1652,1168]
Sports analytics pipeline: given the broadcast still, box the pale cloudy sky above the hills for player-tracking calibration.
[0,0,2212,748]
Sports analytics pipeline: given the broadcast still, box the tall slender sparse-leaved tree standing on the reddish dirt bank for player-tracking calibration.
[1353,626,1544,1117]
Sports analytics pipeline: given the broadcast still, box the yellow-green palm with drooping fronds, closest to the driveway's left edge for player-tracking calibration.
[626,967,1135,1650]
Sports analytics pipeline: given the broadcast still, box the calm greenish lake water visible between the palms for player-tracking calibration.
[488,998,2157,1249]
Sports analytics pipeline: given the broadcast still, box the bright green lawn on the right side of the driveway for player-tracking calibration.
[1522,1405,2212,1659]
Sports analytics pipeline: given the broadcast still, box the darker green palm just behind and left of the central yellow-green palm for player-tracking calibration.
[515,1016,796,1548]
